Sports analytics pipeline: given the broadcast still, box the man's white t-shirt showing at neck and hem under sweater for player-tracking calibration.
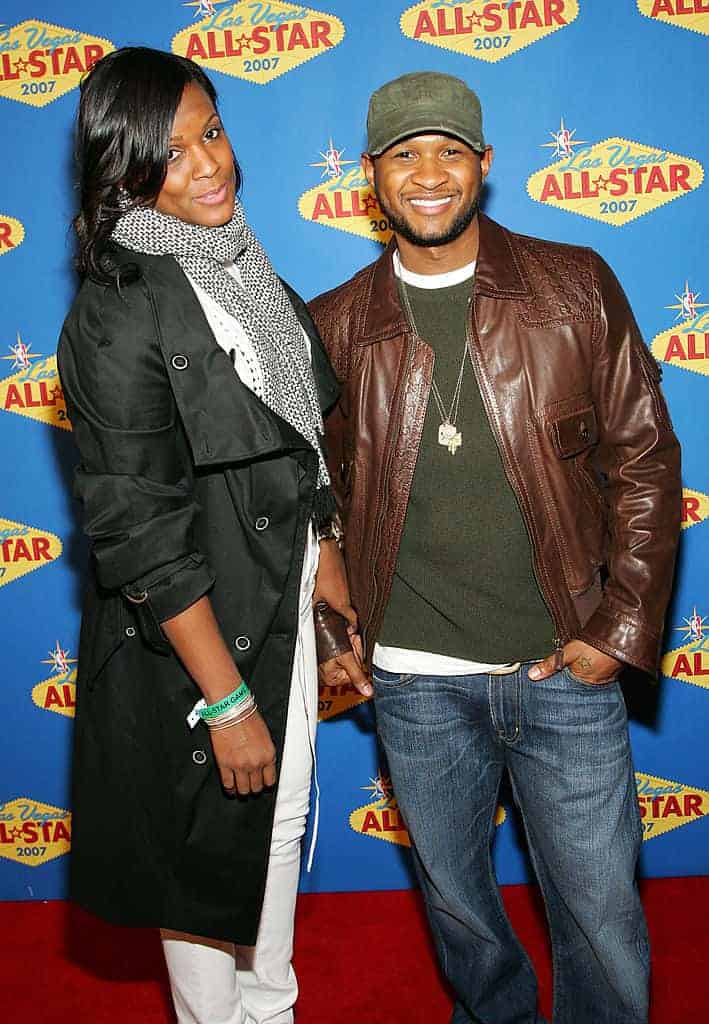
[372,252,511,676]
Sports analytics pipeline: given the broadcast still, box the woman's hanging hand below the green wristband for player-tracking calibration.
[209,712,276,797]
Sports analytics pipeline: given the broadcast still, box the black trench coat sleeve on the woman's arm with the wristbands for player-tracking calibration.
[57,280,214,626]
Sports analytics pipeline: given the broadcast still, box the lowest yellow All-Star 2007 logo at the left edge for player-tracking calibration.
[0,797,72,867]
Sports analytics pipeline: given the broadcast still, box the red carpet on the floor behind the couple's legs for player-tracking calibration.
[0,879,709,1024]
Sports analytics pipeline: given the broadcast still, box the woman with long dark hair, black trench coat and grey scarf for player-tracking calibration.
[58,48,362,1024]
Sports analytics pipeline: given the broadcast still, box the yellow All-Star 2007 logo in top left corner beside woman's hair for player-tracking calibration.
[0,18,115,106]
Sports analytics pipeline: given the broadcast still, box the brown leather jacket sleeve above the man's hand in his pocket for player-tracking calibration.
[580,257,681,675]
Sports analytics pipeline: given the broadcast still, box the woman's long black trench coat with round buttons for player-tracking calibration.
[58,250,337,944]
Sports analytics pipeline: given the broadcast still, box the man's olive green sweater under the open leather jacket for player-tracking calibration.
[378,279,554,664]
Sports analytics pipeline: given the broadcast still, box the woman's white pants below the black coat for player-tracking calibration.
[161,538,318,1024]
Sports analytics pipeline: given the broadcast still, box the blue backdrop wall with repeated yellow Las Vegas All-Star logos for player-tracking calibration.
[0,0,709,899]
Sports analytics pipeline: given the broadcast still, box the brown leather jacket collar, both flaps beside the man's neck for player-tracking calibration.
[360,213,531,345]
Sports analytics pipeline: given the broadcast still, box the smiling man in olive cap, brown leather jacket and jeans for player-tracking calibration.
[310,73,680,1024]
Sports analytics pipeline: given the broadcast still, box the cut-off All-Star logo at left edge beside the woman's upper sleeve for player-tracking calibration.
[0,333,72,430]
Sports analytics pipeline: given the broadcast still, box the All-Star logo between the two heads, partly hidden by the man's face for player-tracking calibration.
[298,139,391,245]
